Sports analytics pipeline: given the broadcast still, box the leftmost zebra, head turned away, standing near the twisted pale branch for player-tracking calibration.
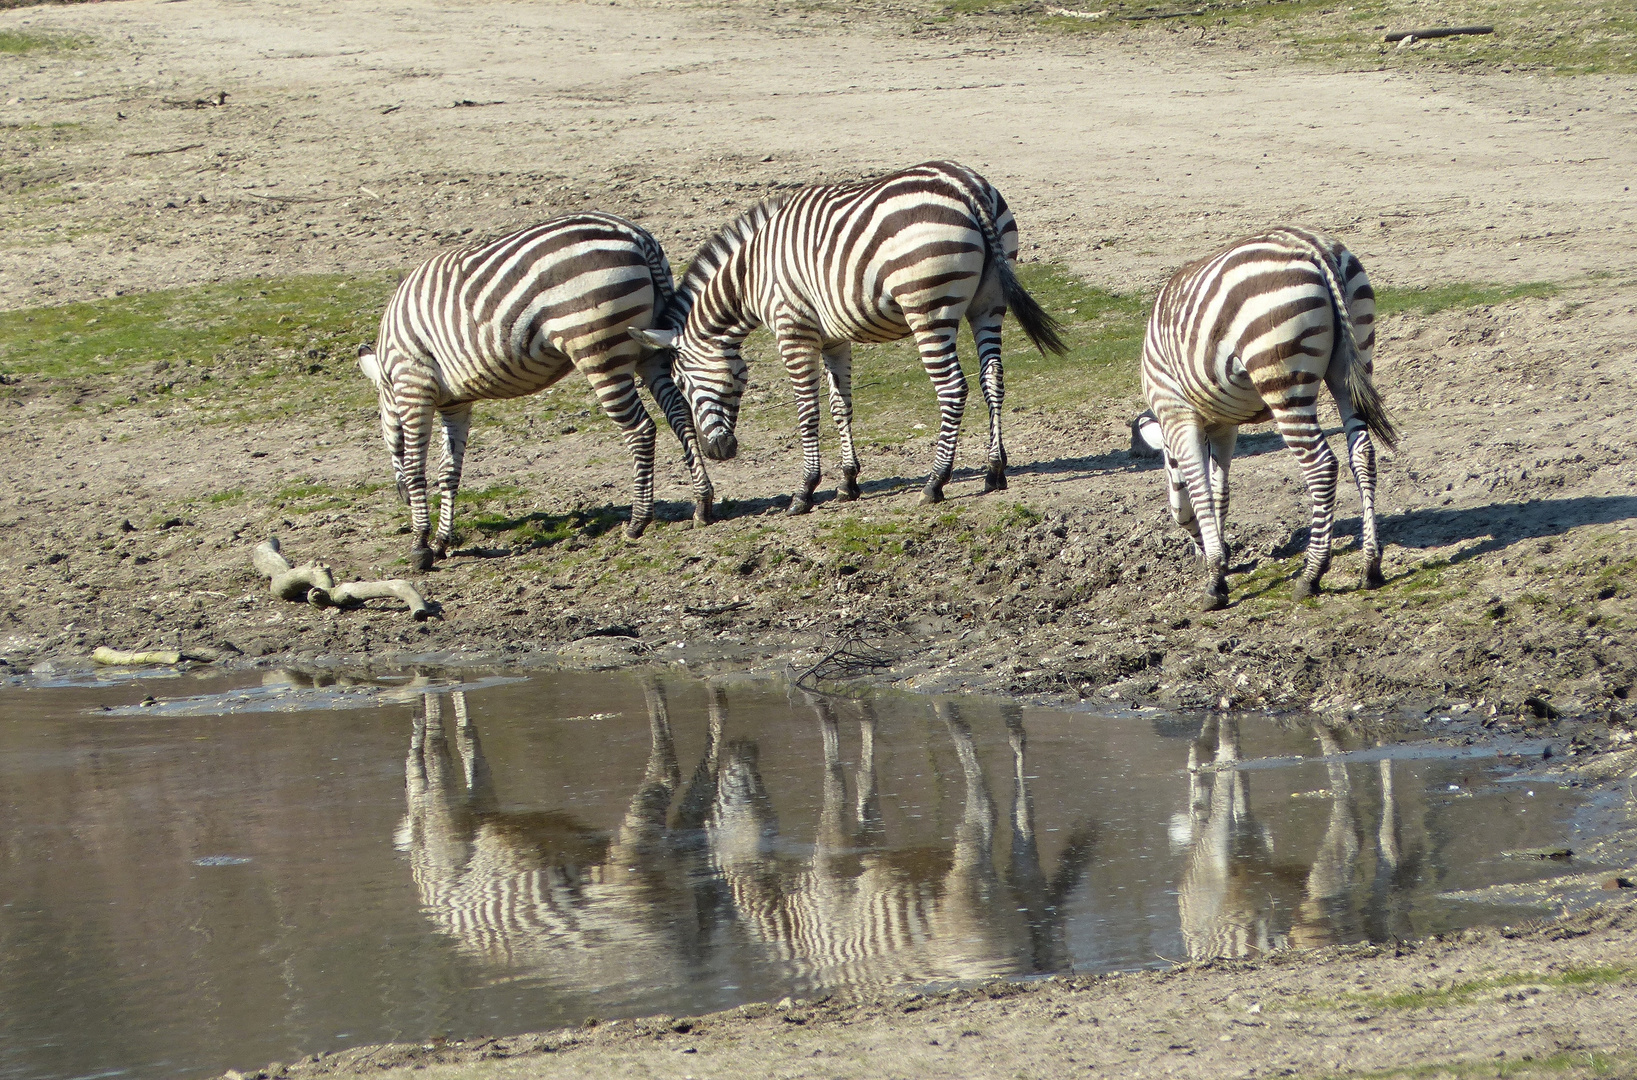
[359,213,712,569]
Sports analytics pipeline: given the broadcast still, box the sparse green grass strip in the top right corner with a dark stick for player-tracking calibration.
[938,0,1637,75]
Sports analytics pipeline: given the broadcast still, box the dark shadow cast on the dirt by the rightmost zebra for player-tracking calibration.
[1272,496,1637,565]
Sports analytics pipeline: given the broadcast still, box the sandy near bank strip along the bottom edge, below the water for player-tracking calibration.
[239,903,1637,1080]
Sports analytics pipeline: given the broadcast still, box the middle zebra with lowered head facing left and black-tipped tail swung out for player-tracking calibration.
[632,162,1066,514]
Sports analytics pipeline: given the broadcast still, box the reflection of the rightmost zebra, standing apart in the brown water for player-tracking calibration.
[1177,715,1421,959]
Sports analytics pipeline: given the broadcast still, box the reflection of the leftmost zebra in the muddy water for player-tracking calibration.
[398,684,712,990]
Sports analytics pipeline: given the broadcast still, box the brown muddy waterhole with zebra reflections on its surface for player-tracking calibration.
[0,674,1576,1080]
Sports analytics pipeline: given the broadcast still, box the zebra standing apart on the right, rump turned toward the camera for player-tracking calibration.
[1133,227,1398,610]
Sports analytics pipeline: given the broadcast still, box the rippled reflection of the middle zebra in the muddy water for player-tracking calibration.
[707,697,1090,988]
